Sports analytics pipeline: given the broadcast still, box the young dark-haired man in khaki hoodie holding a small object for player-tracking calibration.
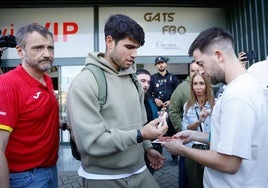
[67,14,168,188]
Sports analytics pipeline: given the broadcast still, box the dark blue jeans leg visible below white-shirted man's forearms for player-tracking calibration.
[178,156,189,188]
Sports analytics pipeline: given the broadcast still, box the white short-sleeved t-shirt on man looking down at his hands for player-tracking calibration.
[203,73,268,188]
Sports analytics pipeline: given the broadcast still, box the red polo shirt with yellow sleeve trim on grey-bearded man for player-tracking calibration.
[0,65,59,172]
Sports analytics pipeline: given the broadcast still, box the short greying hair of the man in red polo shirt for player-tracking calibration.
[15,23,53,48]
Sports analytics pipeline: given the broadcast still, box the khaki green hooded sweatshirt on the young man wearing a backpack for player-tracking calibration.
[67,53,152,175]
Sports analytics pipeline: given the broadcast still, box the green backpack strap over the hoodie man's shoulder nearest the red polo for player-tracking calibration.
[82,64,107,109]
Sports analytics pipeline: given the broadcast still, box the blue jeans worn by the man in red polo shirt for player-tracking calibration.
[9,165,58,188]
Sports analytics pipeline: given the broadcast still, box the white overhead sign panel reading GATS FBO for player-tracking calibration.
[99,7,225,56]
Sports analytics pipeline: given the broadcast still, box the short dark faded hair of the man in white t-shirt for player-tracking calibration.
[188,27,233,56]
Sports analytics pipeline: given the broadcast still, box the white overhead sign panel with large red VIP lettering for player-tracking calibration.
[0,7,94,59]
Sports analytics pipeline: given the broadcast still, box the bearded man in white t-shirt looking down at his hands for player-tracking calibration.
[163,27,268,188]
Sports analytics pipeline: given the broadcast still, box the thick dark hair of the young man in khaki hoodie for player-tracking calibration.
[104,14,145,46]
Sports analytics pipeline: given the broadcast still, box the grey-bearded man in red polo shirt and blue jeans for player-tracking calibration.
[0,24,59,188]
